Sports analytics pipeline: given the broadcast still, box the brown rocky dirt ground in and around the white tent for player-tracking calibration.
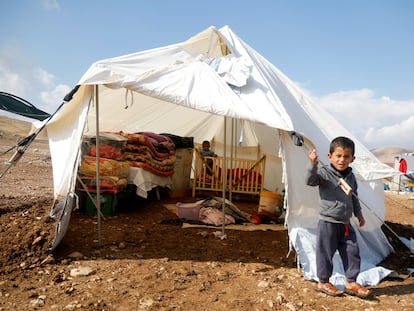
[0,117,414,311]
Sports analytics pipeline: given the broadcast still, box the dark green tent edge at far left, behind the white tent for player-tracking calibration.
[0,92,50,121]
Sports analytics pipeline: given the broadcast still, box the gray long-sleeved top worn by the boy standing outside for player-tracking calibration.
[306,163,362,224]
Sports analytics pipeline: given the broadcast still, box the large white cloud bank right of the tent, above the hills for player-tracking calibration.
[316,89,414,149]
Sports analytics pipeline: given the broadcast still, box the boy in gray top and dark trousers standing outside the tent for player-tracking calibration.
[306,137,371,298]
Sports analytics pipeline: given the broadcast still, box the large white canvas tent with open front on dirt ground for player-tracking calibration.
[38,26,395,284]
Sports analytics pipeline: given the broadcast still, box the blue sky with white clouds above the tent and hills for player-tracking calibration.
[0,0,414,149]
